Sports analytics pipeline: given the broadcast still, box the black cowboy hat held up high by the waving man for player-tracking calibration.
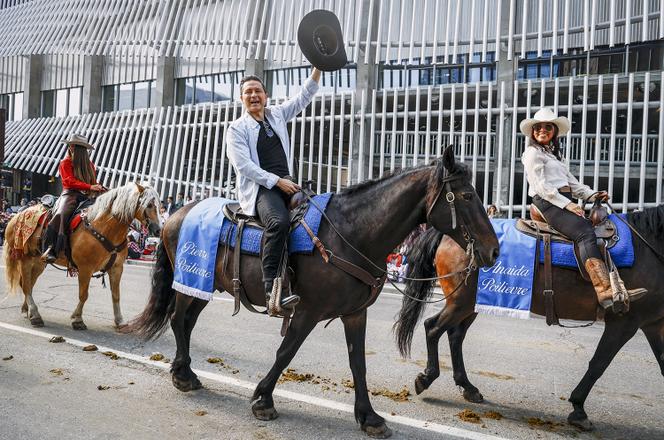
[297,9,348,72]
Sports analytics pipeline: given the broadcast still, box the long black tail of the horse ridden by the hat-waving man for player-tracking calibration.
[123,241,175,339]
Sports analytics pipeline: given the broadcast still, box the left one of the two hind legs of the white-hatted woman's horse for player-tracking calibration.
[415,307,461,394]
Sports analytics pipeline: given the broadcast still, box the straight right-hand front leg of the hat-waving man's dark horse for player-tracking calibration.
[341,310,392,438]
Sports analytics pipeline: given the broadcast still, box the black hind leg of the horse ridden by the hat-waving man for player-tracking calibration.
[171,292,194,392]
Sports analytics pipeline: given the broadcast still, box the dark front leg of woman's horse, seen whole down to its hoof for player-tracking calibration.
[567,317,638,431]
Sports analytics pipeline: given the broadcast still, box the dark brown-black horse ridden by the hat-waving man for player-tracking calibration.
[129,147,498,438]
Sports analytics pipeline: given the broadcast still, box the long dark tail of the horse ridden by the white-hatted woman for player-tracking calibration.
[394,228,443,357]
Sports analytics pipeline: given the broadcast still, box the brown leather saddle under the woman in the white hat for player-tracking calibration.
[516,200,620,325]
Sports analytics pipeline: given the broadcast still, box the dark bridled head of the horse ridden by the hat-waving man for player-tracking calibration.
[427,146,499,266]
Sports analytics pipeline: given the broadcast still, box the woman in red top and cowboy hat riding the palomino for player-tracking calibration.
[43,134,103,263]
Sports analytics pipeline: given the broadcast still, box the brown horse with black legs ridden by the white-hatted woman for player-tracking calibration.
[395,205,664,430]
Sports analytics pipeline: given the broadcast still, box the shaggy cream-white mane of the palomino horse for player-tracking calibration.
[87,182,159,223]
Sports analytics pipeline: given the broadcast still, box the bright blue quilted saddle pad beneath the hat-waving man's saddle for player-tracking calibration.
[219,193,332,255]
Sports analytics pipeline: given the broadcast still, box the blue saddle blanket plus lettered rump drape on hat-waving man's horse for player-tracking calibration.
[172,193,332,301]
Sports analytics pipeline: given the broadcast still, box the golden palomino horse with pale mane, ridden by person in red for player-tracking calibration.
[5,183,160,330]
